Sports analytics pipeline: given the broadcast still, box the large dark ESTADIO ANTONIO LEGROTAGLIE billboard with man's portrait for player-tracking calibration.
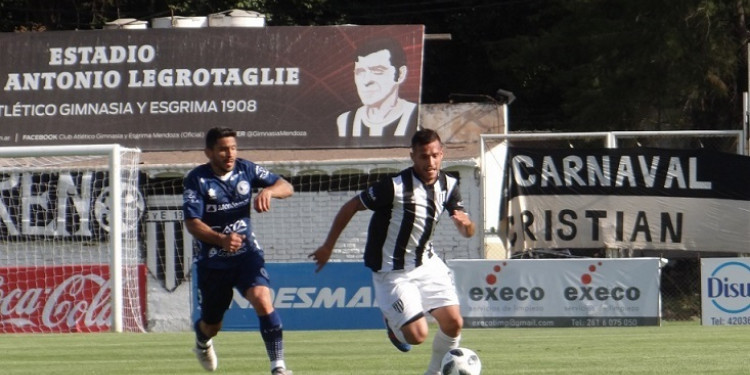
[0,25,424,150]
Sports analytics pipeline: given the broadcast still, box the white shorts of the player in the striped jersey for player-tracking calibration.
[372,257,458,330]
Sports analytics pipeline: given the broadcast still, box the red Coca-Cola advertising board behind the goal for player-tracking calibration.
[0,265,146,333]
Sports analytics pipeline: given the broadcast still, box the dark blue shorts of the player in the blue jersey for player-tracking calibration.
[196,251,270,324]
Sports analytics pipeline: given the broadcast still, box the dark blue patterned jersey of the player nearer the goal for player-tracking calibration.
[182,159,279,268]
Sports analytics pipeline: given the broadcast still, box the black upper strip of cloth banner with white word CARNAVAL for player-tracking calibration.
[509,147,750,200]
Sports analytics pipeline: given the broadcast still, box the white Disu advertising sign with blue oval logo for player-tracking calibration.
[701,258,750,326]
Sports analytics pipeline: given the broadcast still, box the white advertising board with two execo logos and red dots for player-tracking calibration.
[448,258,661,328]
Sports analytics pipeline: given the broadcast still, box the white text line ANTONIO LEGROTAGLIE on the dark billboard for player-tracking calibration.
[3,67,300,91]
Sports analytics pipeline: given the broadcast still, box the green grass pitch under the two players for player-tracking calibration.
[0,322,750,375]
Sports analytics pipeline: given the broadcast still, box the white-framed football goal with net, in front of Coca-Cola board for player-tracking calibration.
[0,145,146,333]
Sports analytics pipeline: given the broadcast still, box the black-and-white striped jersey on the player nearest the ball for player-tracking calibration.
[359,168,464,272]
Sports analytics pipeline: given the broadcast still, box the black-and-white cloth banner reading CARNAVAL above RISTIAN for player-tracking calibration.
[501,148,750,252]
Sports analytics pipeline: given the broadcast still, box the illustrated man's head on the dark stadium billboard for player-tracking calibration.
[354,49,406,106]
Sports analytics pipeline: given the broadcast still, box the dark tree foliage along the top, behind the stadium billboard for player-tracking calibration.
[0,0,750,130]
